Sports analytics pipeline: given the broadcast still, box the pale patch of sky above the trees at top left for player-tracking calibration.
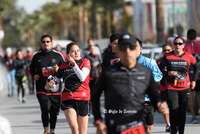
[16,0,60,14]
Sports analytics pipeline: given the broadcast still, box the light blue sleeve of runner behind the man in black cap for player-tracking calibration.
[149,59,163,82]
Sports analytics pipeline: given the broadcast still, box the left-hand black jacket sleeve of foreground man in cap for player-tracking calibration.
[91,72,106,121]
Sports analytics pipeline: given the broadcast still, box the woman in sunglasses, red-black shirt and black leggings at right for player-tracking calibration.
[160,37,198,134]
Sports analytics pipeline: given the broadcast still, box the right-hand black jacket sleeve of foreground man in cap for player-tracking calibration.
[147,74,161,109]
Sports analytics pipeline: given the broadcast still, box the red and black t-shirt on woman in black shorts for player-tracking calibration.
[56,58,91,101]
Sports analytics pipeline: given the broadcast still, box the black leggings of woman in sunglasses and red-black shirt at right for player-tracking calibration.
[166,89,190,134]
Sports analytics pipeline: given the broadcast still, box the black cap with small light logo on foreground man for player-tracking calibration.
[118,33,137,46]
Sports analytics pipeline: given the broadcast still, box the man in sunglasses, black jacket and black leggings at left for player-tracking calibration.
[29,35,64,134]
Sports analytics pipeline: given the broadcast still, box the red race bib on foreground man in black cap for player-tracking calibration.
[121,125,145,134]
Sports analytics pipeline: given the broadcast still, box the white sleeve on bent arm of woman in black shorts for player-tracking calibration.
[73,60,91,81]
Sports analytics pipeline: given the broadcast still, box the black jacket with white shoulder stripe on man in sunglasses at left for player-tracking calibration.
[29,49,64,93]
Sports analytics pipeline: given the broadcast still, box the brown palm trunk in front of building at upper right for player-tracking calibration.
[156,0,165,45]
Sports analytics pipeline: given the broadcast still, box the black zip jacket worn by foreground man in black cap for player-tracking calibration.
[92,63,160,125]
